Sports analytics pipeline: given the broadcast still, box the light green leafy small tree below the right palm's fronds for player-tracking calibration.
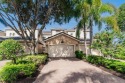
[92,31,115,56]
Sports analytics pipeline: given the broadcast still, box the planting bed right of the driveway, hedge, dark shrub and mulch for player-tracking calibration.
[75,51,125,79]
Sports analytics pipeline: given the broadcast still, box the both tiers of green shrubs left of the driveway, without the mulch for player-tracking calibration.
[0,55,47,83]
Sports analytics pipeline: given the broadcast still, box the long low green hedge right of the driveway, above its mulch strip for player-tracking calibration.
[86,56,125,74]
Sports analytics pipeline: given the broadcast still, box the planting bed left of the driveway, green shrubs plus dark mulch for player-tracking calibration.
[0,55,47,83]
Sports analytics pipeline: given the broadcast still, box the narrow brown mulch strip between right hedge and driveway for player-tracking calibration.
[84,60,125,79]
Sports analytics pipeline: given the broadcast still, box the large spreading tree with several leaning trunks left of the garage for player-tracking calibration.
[0,0,77,54]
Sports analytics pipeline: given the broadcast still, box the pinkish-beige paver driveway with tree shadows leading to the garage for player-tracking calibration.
[34,59,125,83]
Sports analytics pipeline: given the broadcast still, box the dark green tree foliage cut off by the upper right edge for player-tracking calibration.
[117,3,125,31]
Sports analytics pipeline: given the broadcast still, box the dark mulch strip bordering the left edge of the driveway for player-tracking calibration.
[14,64,44,83]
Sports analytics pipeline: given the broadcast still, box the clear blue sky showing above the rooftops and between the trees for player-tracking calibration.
[0,0,125,33]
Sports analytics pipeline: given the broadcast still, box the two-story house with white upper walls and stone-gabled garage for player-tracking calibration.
[0,28,90,57]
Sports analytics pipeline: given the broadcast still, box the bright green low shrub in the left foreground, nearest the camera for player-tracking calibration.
[0,63,36,83]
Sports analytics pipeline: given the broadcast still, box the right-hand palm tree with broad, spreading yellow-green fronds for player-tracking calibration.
[89,0,118,52]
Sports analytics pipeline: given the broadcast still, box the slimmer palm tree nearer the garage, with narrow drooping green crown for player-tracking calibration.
[76,0,90,55]
